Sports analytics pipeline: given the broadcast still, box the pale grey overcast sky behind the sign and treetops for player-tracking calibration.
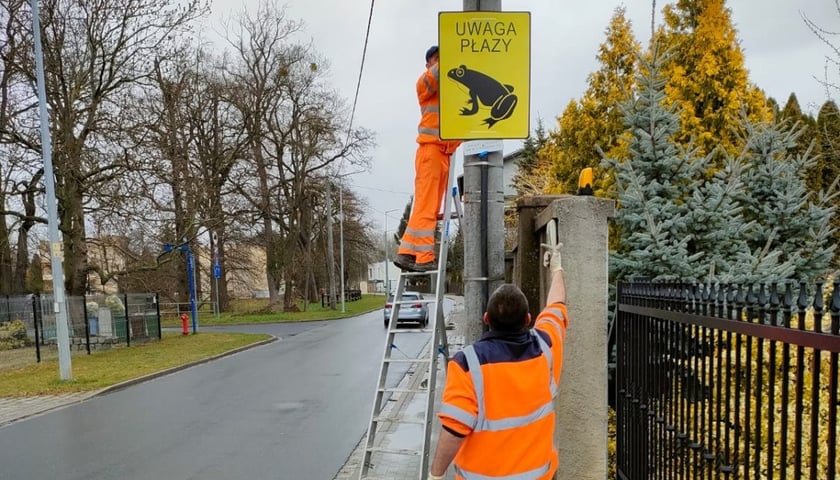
[210,0,840,230]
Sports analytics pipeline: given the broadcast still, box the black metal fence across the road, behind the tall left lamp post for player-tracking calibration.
[0,293,161,362]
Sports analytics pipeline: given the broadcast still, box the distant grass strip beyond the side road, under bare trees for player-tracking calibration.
[161,295,385,327]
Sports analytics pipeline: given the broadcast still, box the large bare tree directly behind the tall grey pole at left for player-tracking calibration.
[0,0,208,295]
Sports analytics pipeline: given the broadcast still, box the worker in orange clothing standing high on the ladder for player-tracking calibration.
[394,46,461,272]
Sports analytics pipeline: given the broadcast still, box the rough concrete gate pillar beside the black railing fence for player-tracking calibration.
[535,196,615,480]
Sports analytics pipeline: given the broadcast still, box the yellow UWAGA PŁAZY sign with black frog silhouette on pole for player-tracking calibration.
[438,11,531,140]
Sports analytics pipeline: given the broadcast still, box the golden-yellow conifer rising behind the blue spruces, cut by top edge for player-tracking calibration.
[657,0,771,159]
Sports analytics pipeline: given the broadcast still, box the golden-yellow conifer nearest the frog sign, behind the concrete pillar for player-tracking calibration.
[540,8,640,196]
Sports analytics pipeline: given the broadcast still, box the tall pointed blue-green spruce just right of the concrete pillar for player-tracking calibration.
[604,49,706,280]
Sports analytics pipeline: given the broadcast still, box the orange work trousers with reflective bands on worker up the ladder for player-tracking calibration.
[398,143,451,263]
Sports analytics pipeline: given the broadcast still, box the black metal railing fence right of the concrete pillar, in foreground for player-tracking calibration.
[617,279,840,480]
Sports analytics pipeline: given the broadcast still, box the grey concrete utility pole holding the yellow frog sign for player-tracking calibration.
[460,0,505,344]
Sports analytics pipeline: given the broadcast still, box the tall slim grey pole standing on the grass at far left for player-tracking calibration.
[32,0,73,380]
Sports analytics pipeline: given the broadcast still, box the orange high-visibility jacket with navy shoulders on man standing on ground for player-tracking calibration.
[438,303,568,480]
